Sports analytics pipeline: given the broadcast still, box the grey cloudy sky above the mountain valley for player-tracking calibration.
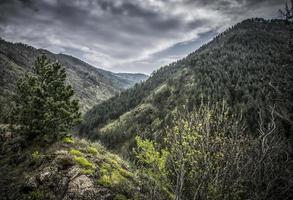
[0,0,286,74]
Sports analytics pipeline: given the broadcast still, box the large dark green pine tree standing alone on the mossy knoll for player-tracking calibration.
[13,55,81,141]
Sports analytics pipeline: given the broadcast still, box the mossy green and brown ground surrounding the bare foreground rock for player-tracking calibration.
[0,133,144,199]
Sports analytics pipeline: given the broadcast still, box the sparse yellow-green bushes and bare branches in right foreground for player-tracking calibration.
[135,101,292,200]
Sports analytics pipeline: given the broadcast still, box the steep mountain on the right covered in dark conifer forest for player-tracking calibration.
[80,19,293,155]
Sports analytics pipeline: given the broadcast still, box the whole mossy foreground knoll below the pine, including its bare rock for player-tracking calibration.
[0,127,154,200]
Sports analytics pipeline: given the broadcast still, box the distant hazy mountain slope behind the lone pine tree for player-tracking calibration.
[0,39,147,112]
